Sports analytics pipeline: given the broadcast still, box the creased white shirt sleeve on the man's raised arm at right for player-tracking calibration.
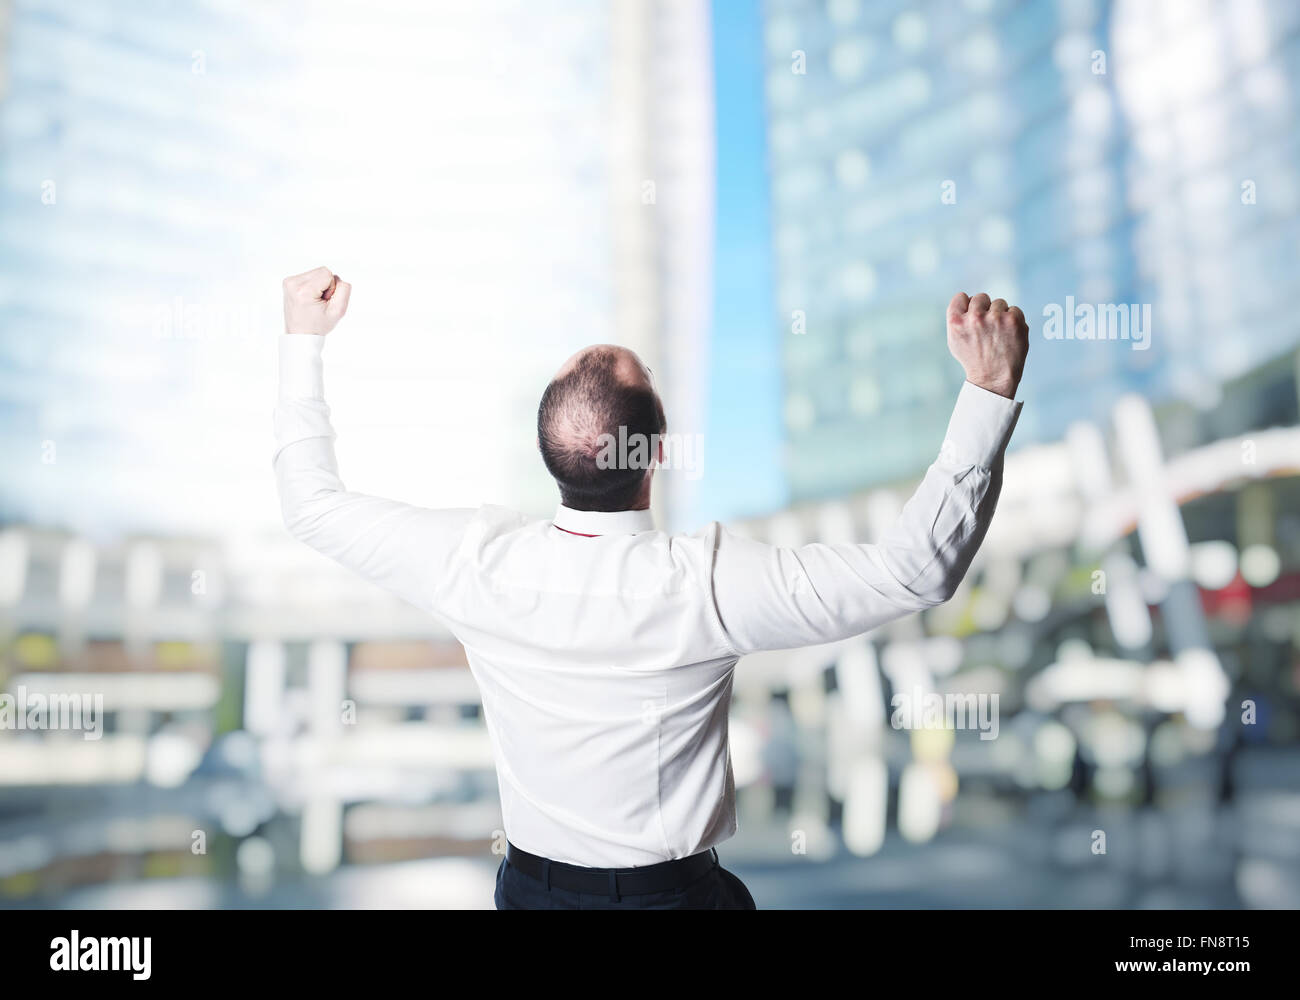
[714,382,1021,654]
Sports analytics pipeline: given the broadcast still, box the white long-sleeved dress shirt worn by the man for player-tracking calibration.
[274,334,1021,867]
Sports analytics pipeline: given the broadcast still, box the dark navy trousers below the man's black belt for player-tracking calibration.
[494,853,755,910]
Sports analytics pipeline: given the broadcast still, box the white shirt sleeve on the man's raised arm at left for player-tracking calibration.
[272,334,476,610]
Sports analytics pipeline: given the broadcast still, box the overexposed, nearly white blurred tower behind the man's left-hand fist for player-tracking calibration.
[0,0,714,533]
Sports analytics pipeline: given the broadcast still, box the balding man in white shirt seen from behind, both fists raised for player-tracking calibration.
[274,268,1028,909]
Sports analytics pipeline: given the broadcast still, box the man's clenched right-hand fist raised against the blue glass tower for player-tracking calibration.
[948,291,1030,399]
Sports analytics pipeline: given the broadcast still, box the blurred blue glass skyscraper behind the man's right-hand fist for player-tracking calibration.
[766,0,1300,501]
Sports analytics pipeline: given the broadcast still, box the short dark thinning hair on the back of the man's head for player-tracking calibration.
[537,347,666,511]
